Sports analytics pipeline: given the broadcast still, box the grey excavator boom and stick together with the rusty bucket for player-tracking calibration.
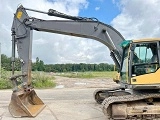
[9,5,124,117]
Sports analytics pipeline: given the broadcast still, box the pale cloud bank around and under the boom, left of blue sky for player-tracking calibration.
[0,0,112,64]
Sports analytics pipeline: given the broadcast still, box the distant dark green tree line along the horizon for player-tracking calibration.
[1,54,115,72]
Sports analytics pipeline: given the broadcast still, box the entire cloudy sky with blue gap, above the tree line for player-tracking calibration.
[0,0,160,64]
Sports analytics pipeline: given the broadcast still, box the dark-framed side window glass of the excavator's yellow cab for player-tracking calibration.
[132,42,158,76]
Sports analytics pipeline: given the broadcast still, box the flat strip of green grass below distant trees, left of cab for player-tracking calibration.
[58,71,117,78]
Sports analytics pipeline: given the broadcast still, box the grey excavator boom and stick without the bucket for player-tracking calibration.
[12,6,124,81]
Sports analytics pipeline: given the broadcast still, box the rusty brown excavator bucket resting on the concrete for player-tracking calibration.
[9,90,45,117]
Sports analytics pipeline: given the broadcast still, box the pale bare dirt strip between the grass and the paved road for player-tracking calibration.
[55,76,118,88]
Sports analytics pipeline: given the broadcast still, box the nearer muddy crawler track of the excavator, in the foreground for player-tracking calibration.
[102,93,160,120]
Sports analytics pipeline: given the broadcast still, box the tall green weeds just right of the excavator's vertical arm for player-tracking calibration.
[32,72,56,88]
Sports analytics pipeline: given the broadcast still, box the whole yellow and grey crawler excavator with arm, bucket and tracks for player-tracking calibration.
[9,5,160,120]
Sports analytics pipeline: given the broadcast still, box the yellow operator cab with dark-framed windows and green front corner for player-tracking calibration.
[120,39,160,84]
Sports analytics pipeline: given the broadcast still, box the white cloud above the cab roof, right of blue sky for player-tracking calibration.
[111,0,160,39]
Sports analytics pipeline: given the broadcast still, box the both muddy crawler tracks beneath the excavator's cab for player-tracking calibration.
[94,88,160,120]
